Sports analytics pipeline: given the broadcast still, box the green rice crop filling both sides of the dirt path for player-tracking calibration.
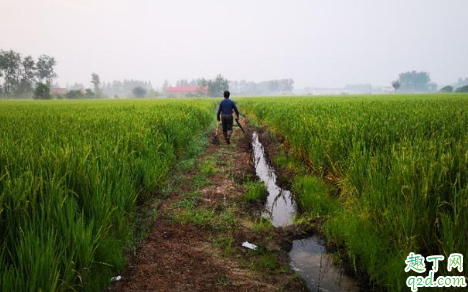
[0,94,468,292]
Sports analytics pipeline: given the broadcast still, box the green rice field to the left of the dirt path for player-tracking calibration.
[0,100,214,292]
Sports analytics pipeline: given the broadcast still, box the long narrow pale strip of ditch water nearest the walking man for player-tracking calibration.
[252,132,297,227]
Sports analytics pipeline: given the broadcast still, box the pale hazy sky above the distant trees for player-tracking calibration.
[0,0,468,88]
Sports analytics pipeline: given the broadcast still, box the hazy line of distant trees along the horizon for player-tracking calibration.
[0,50,468,99]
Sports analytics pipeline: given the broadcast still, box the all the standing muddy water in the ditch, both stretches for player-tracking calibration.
[252,132,360,292]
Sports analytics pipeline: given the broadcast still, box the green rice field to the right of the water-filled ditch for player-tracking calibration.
[241,94,468,291]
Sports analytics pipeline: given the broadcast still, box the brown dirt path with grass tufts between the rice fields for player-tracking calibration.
[109,130,306,292]
